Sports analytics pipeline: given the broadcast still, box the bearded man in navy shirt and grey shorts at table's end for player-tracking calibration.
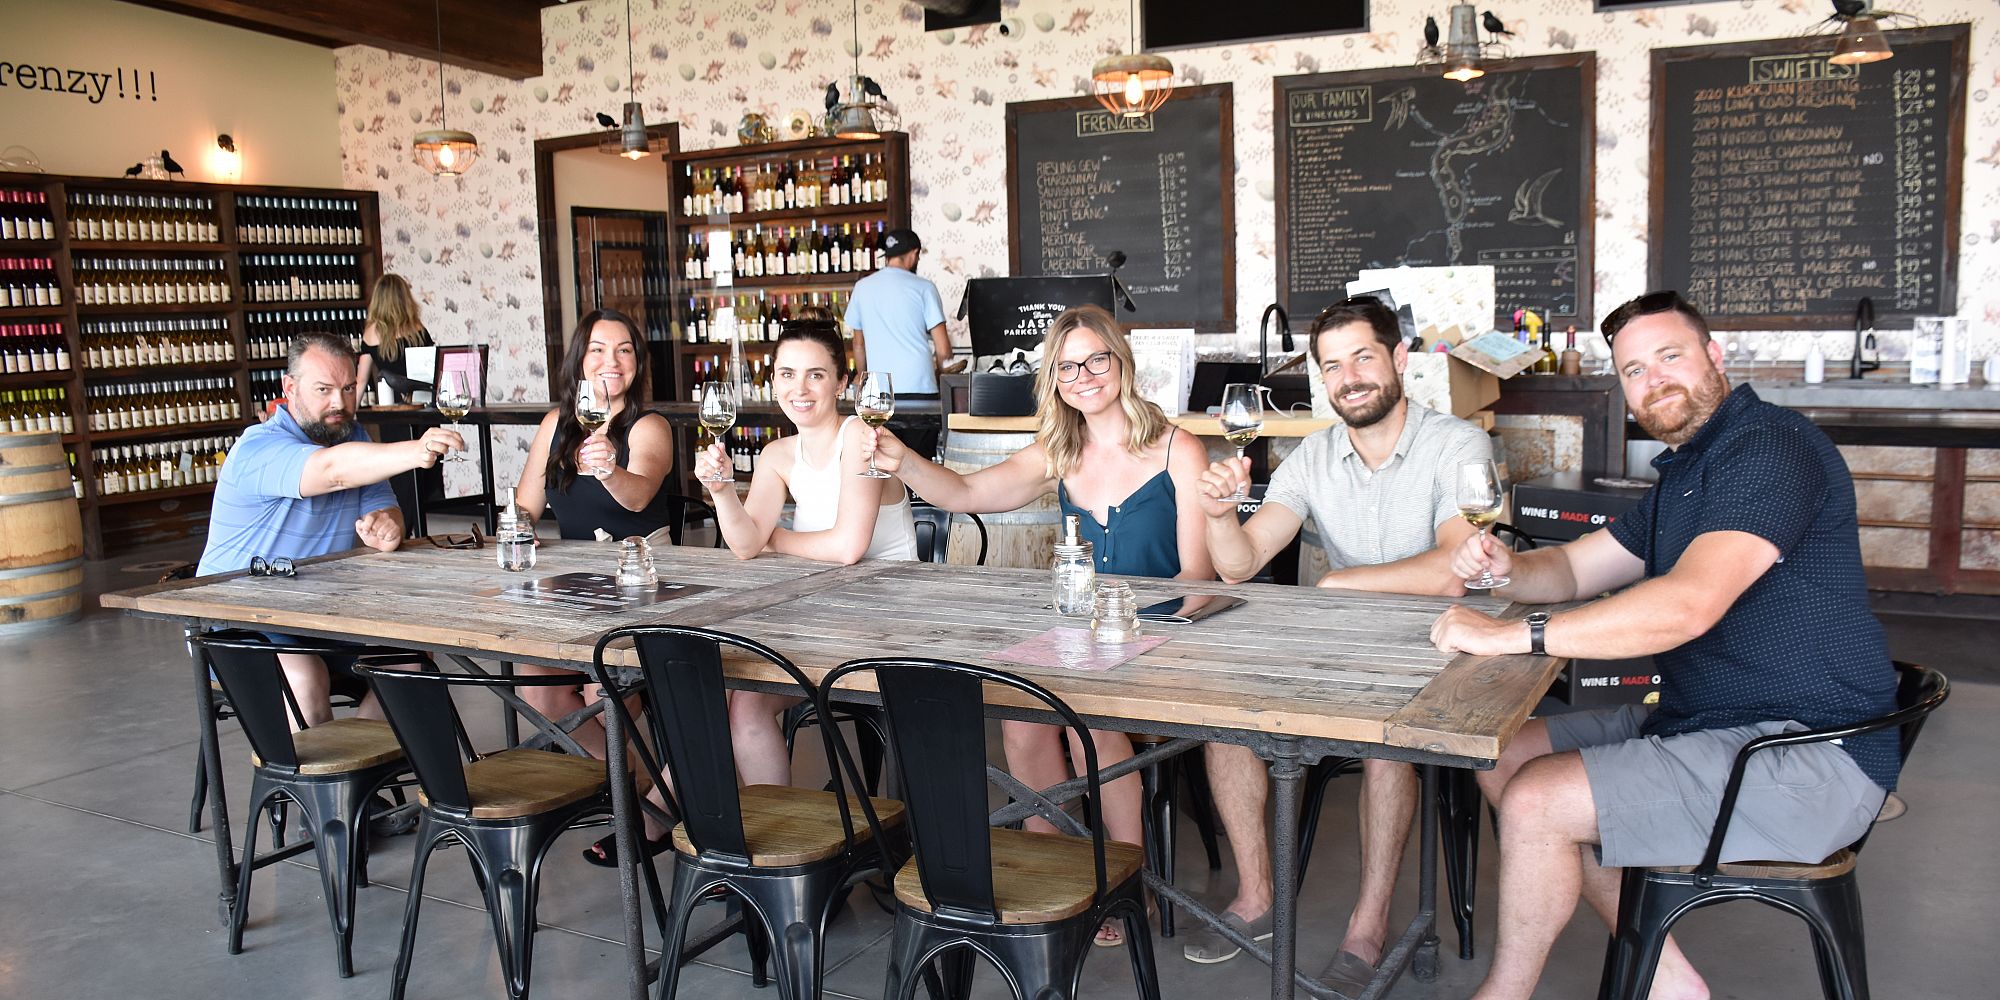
[1432,292,1902,1000]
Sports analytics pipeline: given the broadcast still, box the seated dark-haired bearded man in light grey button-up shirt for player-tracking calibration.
[1184,296,1492,996]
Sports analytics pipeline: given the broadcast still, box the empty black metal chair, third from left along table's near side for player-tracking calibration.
[590,626,902,1000]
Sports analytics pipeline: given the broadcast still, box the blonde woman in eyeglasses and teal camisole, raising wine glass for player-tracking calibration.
[856,306,1214,946]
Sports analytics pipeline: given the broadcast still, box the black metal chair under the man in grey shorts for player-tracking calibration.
[1598,662,1952,1000]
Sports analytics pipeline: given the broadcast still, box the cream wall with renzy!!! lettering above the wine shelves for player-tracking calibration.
[0,0,342,188]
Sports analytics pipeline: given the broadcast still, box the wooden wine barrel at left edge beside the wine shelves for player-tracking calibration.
[0,434,84,638]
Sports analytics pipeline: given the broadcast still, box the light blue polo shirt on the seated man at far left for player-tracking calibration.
[196,406,396,576]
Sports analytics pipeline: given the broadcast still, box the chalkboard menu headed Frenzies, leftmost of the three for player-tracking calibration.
[1006,84,1236,330]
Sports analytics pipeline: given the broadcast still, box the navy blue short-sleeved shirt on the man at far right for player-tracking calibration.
[1608,386,1902,790]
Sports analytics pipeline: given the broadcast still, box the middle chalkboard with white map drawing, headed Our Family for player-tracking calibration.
[1274,52,1596,326]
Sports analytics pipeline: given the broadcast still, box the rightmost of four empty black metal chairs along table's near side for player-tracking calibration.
[820,658,1160,1000]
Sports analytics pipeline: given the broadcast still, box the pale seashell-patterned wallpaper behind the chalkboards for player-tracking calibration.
[334,0,2000,490]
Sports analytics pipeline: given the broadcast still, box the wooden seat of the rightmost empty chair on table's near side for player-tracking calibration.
[896,828,1144,924]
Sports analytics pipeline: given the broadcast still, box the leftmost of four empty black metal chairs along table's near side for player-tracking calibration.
[194,630,416,978]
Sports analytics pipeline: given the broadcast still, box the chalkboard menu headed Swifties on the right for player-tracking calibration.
[1648,24,1968,330]
